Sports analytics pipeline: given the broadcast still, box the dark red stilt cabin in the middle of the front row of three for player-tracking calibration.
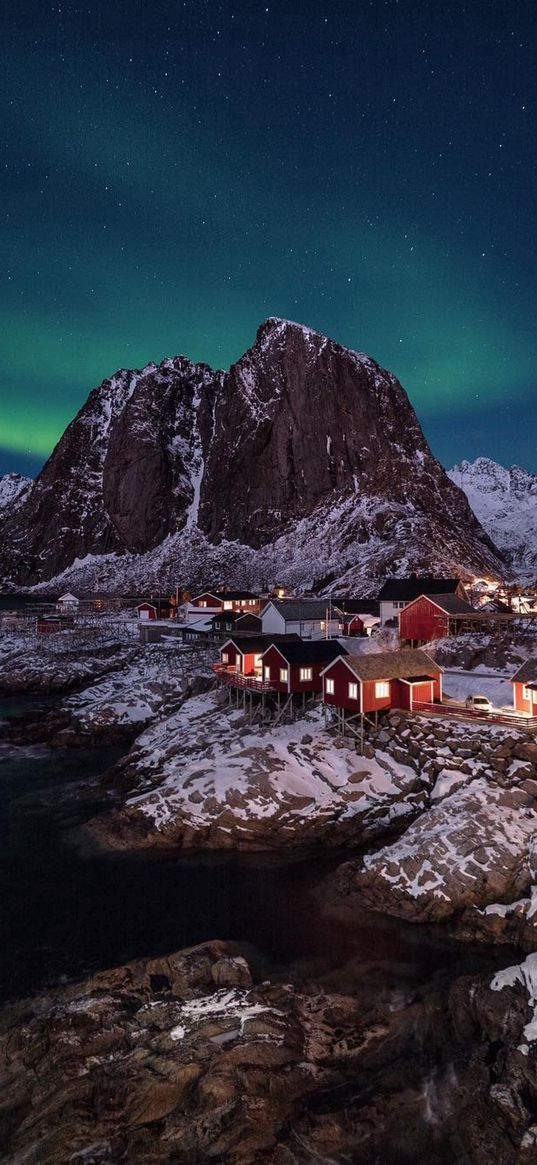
[261,640,347,694]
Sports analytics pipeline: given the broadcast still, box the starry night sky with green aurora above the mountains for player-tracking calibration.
[0,0,537,474]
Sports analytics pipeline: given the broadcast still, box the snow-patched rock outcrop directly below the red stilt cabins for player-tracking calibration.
[90,693,422,845]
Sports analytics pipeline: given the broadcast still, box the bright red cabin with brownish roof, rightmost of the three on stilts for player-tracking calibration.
[322,650,441,714]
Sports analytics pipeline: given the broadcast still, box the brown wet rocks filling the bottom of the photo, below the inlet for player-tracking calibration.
[0,941,537,1165]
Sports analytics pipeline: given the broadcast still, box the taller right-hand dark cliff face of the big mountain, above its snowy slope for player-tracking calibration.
[194,319,476,546]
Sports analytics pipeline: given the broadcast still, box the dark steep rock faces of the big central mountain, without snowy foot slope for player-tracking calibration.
[0,319,503,584]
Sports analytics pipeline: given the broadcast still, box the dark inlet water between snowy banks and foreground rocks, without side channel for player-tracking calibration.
[0,699,513,998]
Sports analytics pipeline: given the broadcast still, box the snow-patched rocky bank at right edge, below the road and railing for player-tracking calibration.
[337,714,537,949]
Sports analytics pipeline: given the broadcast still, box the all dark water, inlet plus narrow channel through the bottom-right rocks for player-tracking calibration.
[0,698,524,1165]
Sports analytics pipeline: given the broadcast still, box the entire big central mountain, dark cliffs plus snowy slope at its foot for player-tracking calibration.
[0,318,503,587]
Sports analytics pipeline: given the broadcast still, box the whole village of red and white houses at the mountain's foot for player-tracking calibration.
[0,573,537,751]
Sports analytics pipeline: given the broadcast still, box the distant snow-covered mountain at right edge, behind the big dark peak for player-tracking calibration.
[448,457,537,579]
